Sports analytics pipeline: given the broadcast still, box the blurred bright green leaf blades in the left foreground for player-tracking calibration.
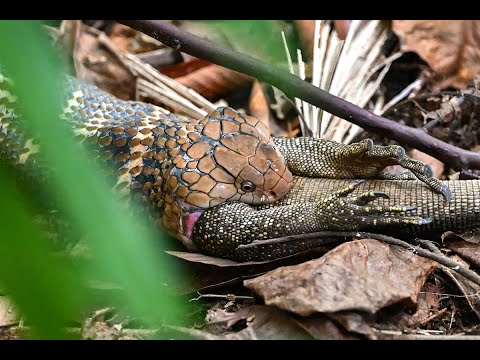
[0,21,183,339]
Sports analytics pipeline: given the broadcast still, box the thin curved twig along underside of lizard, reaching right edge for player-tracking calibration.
[237,231,480,286]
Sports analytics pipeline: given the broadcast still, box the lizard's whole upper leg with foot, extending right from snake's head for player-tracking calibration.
[273,137,451,201]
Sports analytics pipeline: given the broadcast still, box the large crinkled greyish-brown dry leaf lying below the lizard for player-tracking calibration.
[244,239,435,316]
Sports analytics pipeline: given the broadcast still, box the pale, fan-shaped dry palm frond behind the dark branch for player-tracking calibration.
[285,20,412,143]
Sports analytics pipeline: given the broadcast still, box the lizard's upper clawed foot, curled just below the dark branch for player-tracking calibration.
[340,139,452,202]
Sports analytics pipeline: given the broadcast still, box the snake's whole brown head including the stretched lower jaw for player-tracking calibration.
[163,107,293,245]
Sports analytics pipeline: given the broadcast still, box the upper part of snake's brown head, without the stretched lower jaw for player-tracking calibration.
[180,108,292,208]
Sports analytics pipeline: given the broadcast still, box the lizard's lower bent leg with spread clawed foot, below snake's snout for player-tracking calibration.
[192,181,431,261]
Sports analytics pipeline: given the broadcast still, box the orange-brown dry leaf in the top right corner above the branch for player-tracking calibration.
[392,20,480,88]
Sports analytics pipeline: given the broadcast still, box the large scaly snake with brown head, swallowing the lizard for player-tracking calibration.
[0,77,292,249]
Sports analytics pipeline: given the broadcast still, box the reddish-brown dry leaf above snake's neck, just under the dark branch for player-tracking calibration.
[175,64,252,100]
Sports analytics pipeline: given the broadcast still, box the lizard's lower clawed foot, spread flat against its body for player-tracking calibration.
[317,180,432,231]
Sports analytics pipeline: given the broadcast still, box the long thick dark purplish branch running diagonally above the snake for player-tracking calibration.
[117,20,480,170]
